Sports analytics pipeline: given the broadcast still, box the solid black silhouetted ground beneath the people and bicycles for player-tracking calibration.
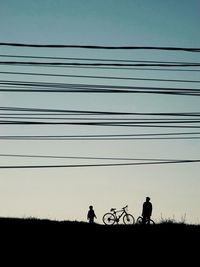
[0,218,200,266]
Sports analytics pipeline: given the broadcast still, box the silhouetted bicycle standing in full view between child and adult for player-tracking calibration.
[103,205,135,225]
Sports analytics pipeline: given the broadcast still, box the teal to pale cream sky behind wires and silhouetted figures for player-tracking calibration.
[0,0,200,224]
